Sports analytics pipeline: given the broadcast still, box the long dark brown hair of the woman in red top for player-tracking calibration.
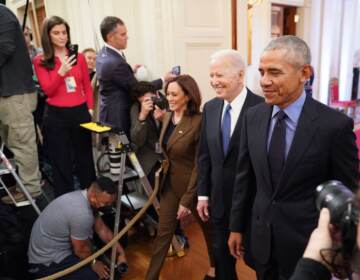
[41,16,71,69]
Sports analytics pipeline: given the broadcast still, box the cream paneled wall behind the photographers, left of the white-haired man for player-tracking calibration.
[40,0,231,101]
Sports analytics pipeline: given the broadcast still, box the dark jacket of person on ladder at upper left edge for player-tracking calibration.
[0,4,36,97]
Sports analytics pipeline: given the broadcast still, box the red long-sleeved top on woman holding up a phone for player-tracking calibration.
[33,53,94,109]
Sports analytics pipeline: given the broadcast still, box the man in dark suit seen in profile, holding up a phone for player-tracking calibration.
[96,17,172,135]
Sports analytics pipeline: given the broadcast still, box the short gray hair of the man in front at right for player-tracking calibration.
[264,35,311,66]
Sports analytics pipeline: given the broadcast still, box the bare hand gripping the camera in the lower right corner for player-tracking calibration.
[304,208,333,263]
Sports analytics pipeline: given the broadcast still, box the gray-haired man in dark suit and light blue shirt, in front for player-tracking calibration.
[228,36,359,280]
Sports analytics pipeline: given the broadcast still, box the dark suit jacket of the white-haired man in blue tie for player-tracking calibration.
[197,90,263,222]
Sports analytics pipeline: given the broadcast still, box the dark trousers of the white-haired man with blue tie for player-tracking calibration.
[212,218,238,280]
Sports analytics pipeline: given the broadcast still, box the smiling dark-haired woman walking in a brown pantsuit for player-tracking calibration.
[146,75,215,280]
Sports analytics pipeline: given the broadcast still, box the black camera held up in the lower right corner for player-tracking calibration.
[316,180,359,260]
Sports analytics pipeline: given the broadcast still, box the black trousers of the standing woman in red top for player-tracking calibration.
[44,104,95,197]
